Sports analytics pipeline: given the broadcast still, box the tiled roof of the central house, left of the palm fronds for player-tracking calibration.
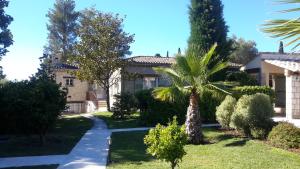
[127,56,175,65]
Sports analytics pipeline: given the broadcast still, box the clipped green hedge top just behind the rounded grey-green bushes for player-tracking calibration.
[232,86,275,103]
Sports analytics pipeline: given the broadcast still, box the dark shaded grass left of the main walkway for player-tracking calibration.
[0,116,93,157]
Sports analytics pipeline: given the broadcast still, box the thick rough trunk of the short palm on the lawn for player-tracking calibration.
[185,90,203,144]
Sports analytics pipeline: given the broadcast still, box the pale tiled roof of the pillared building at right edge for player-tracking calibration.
[260,52,300,62]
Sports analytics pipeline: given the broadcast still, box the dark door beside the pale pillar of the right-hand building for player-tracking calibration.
[274,75,286,108]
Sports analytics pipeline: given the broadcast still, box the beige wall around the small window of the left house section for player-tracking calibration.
[55,70,88,102]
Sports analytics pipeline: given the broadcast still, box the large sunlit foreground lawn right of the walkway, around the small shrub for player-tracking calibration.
[108,129,300,169]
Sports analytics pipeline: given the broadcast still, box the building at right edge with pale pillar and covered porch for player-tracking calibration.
[241,52,300,127]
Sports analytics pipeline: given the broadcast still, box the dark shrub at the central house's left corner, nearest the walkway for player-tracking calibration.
[112,93,136,119]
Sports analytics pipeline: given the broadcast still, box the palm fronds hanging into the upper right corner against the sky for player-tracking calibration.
[262,0,300,50]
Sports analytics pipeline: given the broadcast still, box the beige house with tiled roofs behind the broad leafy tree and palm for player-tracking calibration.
[54,55,240,113]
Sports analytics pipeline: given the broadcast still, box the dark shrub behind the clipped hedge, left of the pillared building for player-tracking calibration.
[226,72,258,86]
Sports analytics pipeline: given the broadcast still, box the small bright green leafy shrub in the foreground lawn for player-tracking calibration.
[144,117,187,169]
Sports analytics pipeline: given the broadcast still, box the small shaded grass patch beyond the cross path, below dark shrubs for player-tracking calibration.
[94,112,141,129]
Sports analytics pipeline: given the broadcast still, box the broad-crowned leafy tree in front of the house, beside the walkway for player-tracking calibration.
[72,8,134,110]
